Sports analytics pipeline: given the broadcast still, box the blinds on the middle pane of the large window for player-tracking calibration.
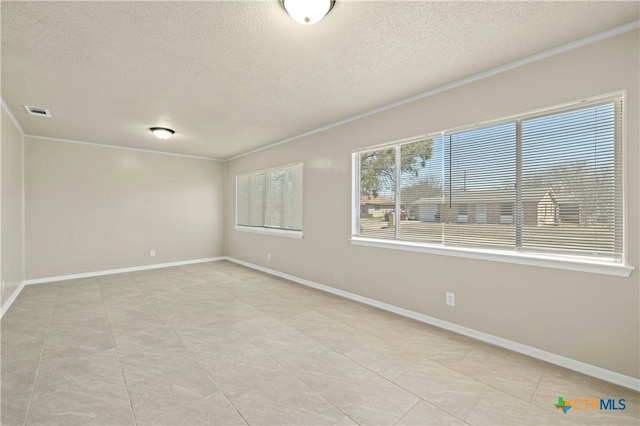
[440,122,516,248]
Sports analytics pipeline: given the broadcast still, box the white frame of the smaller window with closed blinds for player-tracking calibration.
[233,162,304,239]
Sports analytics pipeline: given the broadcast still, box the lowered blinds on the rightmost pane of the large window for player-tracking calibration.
[521,101,622,256]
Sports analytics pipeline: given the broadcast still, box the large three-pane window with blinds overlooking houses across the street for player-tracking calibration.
[353,98,623,261]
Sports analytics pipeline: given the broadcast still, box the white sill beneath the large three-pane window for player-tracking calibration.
[351,236,634,277]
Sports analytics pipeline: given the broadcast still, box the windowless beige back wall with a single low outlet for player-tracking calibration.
[25,137,225,279]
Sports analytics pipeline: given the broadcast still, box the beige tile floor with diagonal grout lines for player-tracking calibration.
[1,261,640,425]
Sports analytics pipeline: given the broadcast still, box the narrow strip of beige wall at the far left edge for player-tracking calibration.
[0,108,24,306]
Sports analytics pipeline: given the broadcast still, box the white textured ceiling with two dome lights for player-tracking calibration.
[1,0,640,159]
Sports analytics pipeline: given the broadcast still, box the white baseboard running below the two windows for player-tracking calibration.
[226,256,640,392]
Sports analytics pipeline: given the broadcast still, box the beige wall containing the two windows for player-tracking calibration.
[226,31,640,378]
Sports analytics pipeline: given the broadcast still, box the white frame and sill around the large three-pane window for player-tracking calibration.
[350,91,635,277]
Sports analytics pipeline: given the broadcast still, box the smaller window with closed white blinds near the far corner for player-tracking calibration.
[236,164,302,233]
